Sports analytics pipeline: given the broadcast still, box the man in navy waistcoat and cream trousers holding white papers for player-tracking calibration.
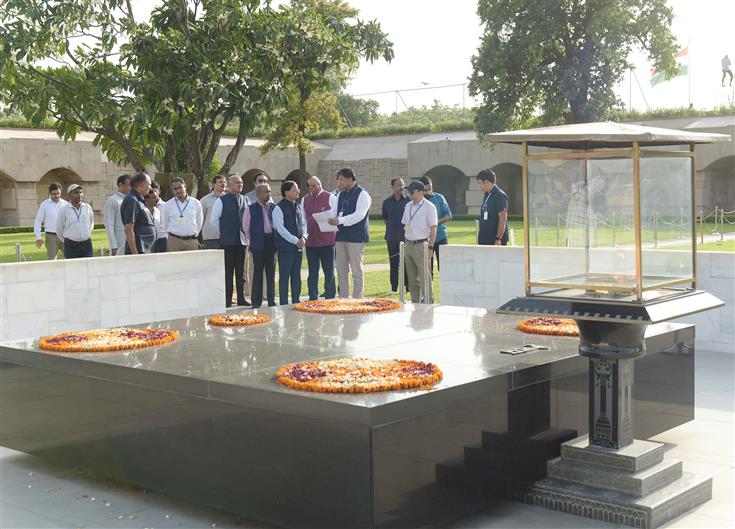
[329,167,372,298]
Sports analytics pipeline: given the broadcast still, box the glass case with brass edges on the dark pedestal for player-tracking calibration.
[522,142,696,301]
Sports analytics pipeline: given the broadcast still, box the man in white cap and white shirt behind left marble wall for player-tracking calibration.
[56,184,94,259]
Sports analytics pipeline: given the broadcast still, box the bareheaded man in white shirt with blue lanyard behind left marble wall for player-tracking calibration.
[163,176,204,252]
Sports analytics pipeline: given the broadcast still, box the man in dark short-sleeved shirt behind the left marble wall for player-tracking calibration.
[120,172,156,255]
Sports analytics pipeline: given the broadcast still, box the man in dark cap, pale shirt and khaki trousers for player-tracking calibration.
[401,181,439,303]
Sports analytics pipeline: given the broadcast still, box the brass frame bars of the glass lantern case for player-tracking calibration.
[521,142,697,301]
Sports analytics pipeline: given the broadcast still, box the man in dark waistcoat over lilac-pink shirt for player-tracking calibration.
[242,184,276,308]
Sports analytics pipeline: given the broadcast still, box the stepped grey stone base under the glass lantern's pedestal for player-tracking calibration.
[514,436,712,529]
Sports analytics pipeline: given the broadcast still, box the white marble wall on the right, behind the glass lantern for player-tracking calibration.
[439,245,735,353]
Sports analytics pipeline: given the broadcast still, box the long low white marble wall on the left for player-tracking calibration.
[0,250,225,340]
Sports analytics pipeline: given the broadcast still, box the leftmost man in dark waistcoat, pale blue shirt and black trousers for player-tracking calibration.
[210,175,250,307]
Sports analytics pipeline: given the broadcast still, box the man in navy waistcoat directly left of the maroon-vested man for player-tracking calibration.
[273,180,309,305]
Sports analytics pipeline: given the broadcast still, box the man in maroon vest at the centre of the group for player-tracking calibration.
[302,176,337,300]
